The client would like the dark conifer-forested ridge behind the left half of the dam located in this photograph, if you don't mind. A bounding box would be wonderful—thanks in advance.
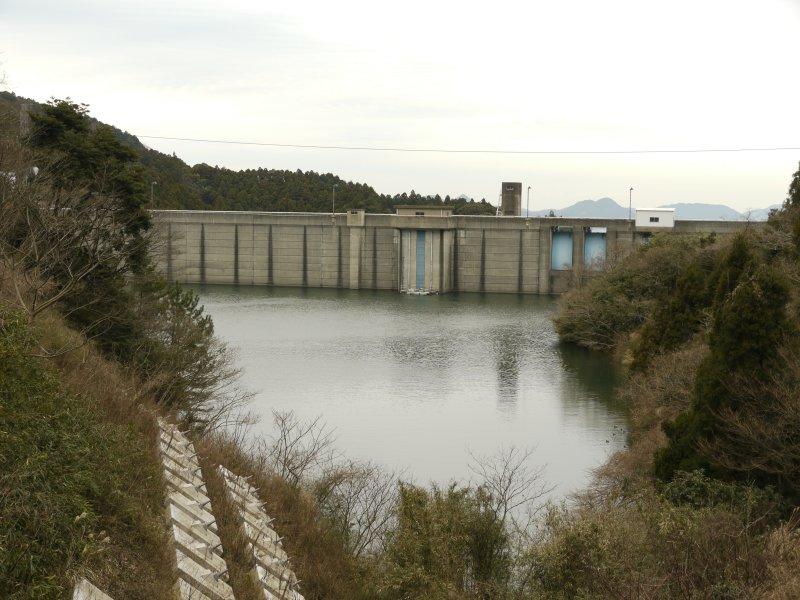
[0,92,496,215]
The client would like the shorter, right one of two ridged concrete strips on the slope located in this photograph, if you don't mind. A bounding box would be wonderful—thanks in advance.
[219,466,304,600]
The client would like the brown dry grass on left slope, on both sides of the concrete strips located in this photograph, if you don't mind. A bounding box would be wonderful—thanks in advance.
[0,258,366,600]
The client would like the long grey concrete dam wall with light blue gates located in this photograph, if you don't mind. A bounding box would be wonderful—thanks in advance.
[152,206,757,294]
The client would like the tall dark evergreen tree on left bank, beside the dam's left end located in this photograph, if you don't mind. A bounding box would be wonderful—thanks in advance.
[28,100,150,358]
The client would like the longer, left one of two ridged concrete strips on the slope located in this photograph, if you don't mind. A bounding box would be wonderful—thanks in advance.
[158,419,234,600]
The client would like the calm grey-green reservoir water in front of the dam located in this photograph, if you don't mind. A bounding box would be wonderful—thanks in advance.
[194,286,626,496]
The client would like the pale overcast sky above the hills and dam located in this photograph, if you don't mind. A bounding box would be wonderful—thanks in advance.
[0,0,800,210]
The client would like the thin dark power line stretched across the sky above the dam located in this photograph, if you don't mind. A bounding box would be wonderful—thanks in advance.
[138,135,800,154]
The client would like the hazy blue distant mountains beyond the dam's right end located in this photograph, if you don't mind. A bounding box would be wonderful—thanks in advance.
[530,198,781,221]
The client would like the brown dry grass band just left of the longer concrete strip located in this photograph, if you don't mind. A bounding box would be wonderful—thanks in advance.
[0,264,173,600]
